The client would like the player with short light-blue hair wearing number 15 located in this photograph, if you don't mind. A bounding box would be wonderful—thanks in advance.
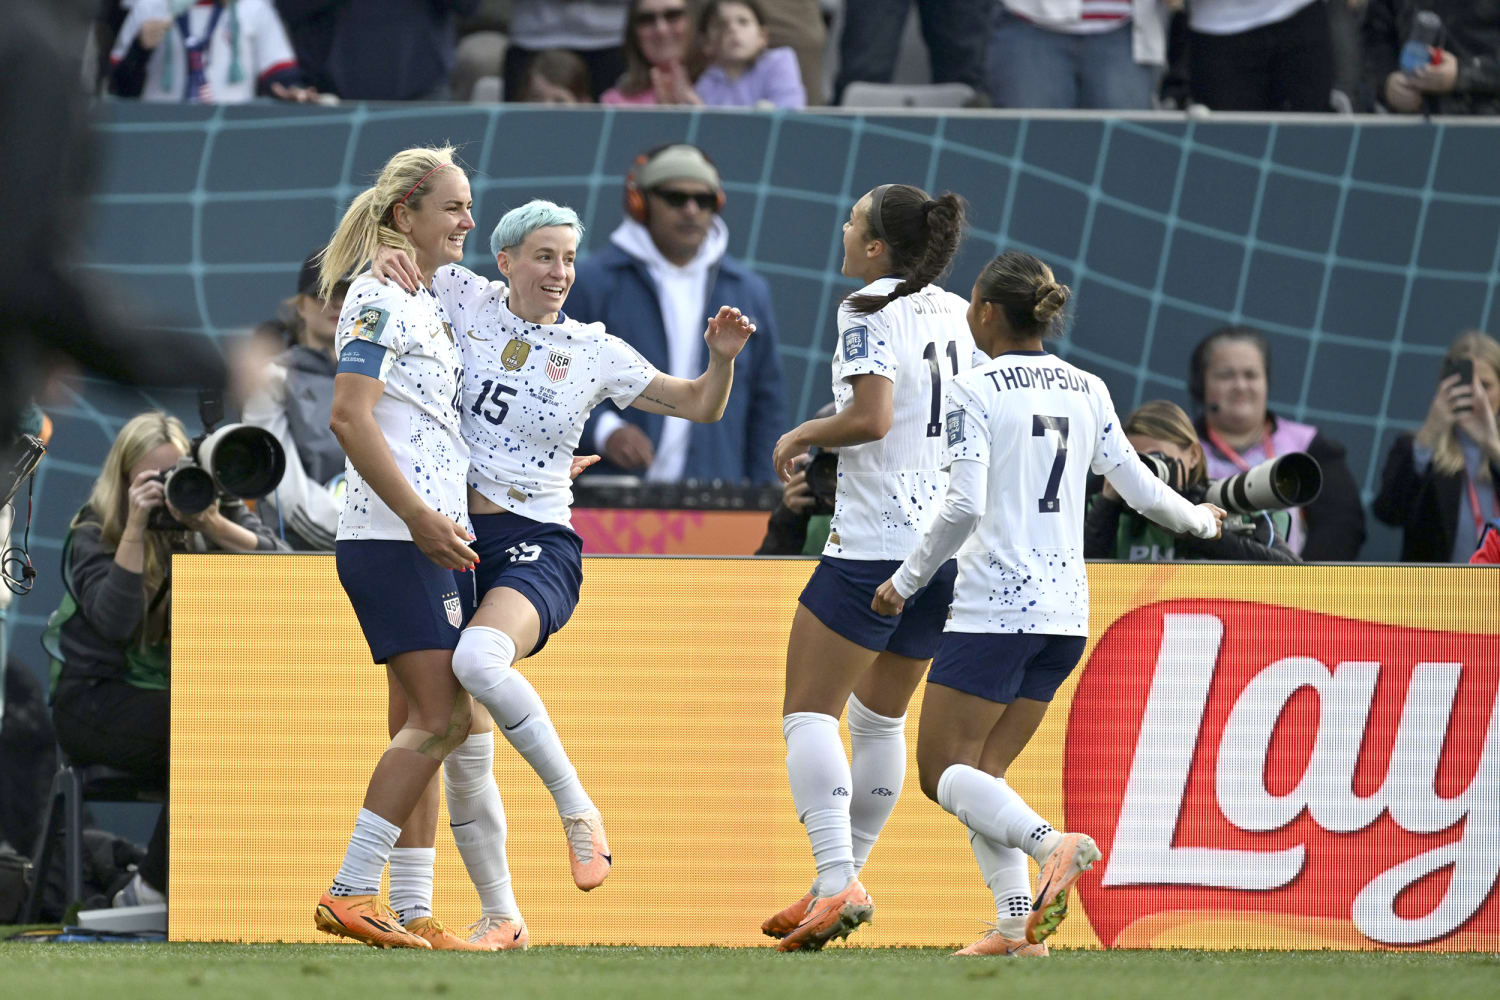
[377,201,755,929]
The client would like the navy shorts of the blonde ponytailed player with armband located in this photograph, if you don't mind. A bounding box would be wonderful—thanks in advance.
[333,538,464,663]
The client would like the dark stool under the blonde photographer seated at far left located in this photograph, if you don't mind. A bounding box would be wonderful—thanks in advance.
[21,750,167,924]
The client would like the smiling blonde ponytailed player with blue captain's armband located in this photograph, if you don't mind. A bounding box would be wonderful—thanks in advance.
[314,147,479,948]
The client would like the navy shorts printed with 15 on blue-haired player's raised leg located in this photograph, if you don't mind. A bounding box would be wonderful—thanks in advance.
[459,511,584,655]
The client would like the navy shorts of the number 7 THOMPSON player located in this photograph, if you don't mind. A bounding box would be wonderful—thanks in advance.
[927,633,1088,705]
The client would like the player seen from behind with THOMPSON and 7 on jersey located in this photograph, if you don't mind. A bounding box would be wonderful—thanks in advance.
[872,250,1224,957]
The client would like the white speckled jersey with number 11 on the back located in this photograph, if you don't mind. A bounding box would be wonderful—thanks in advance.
[824,277,975,559]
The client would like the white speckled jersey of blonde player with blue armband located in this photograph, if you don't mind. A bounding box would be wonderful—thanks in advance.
[336,274,470,541]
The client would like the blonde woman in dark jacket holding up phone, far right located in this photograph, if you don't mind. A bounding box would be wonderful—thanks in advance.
[1374,330,1500,562]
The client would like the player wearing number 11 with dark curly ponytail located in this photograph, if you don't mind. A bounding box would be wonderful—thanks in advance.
[761,184,974,952]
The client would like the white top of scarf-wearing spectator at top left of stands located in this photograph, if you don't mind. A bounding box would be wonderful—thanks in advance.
[110,0,297,103]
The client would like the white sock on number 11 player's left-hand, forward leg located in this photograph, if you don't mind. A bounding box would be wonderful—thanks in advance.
[782,712,855,897]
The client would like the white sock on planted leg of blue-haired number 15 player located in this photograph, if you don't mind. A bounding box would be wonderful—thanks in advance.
[443,732,521,919]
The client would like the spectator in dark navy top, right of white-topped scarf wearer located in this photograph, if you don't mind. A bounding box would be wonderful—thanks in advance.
[276,0,480,100]
